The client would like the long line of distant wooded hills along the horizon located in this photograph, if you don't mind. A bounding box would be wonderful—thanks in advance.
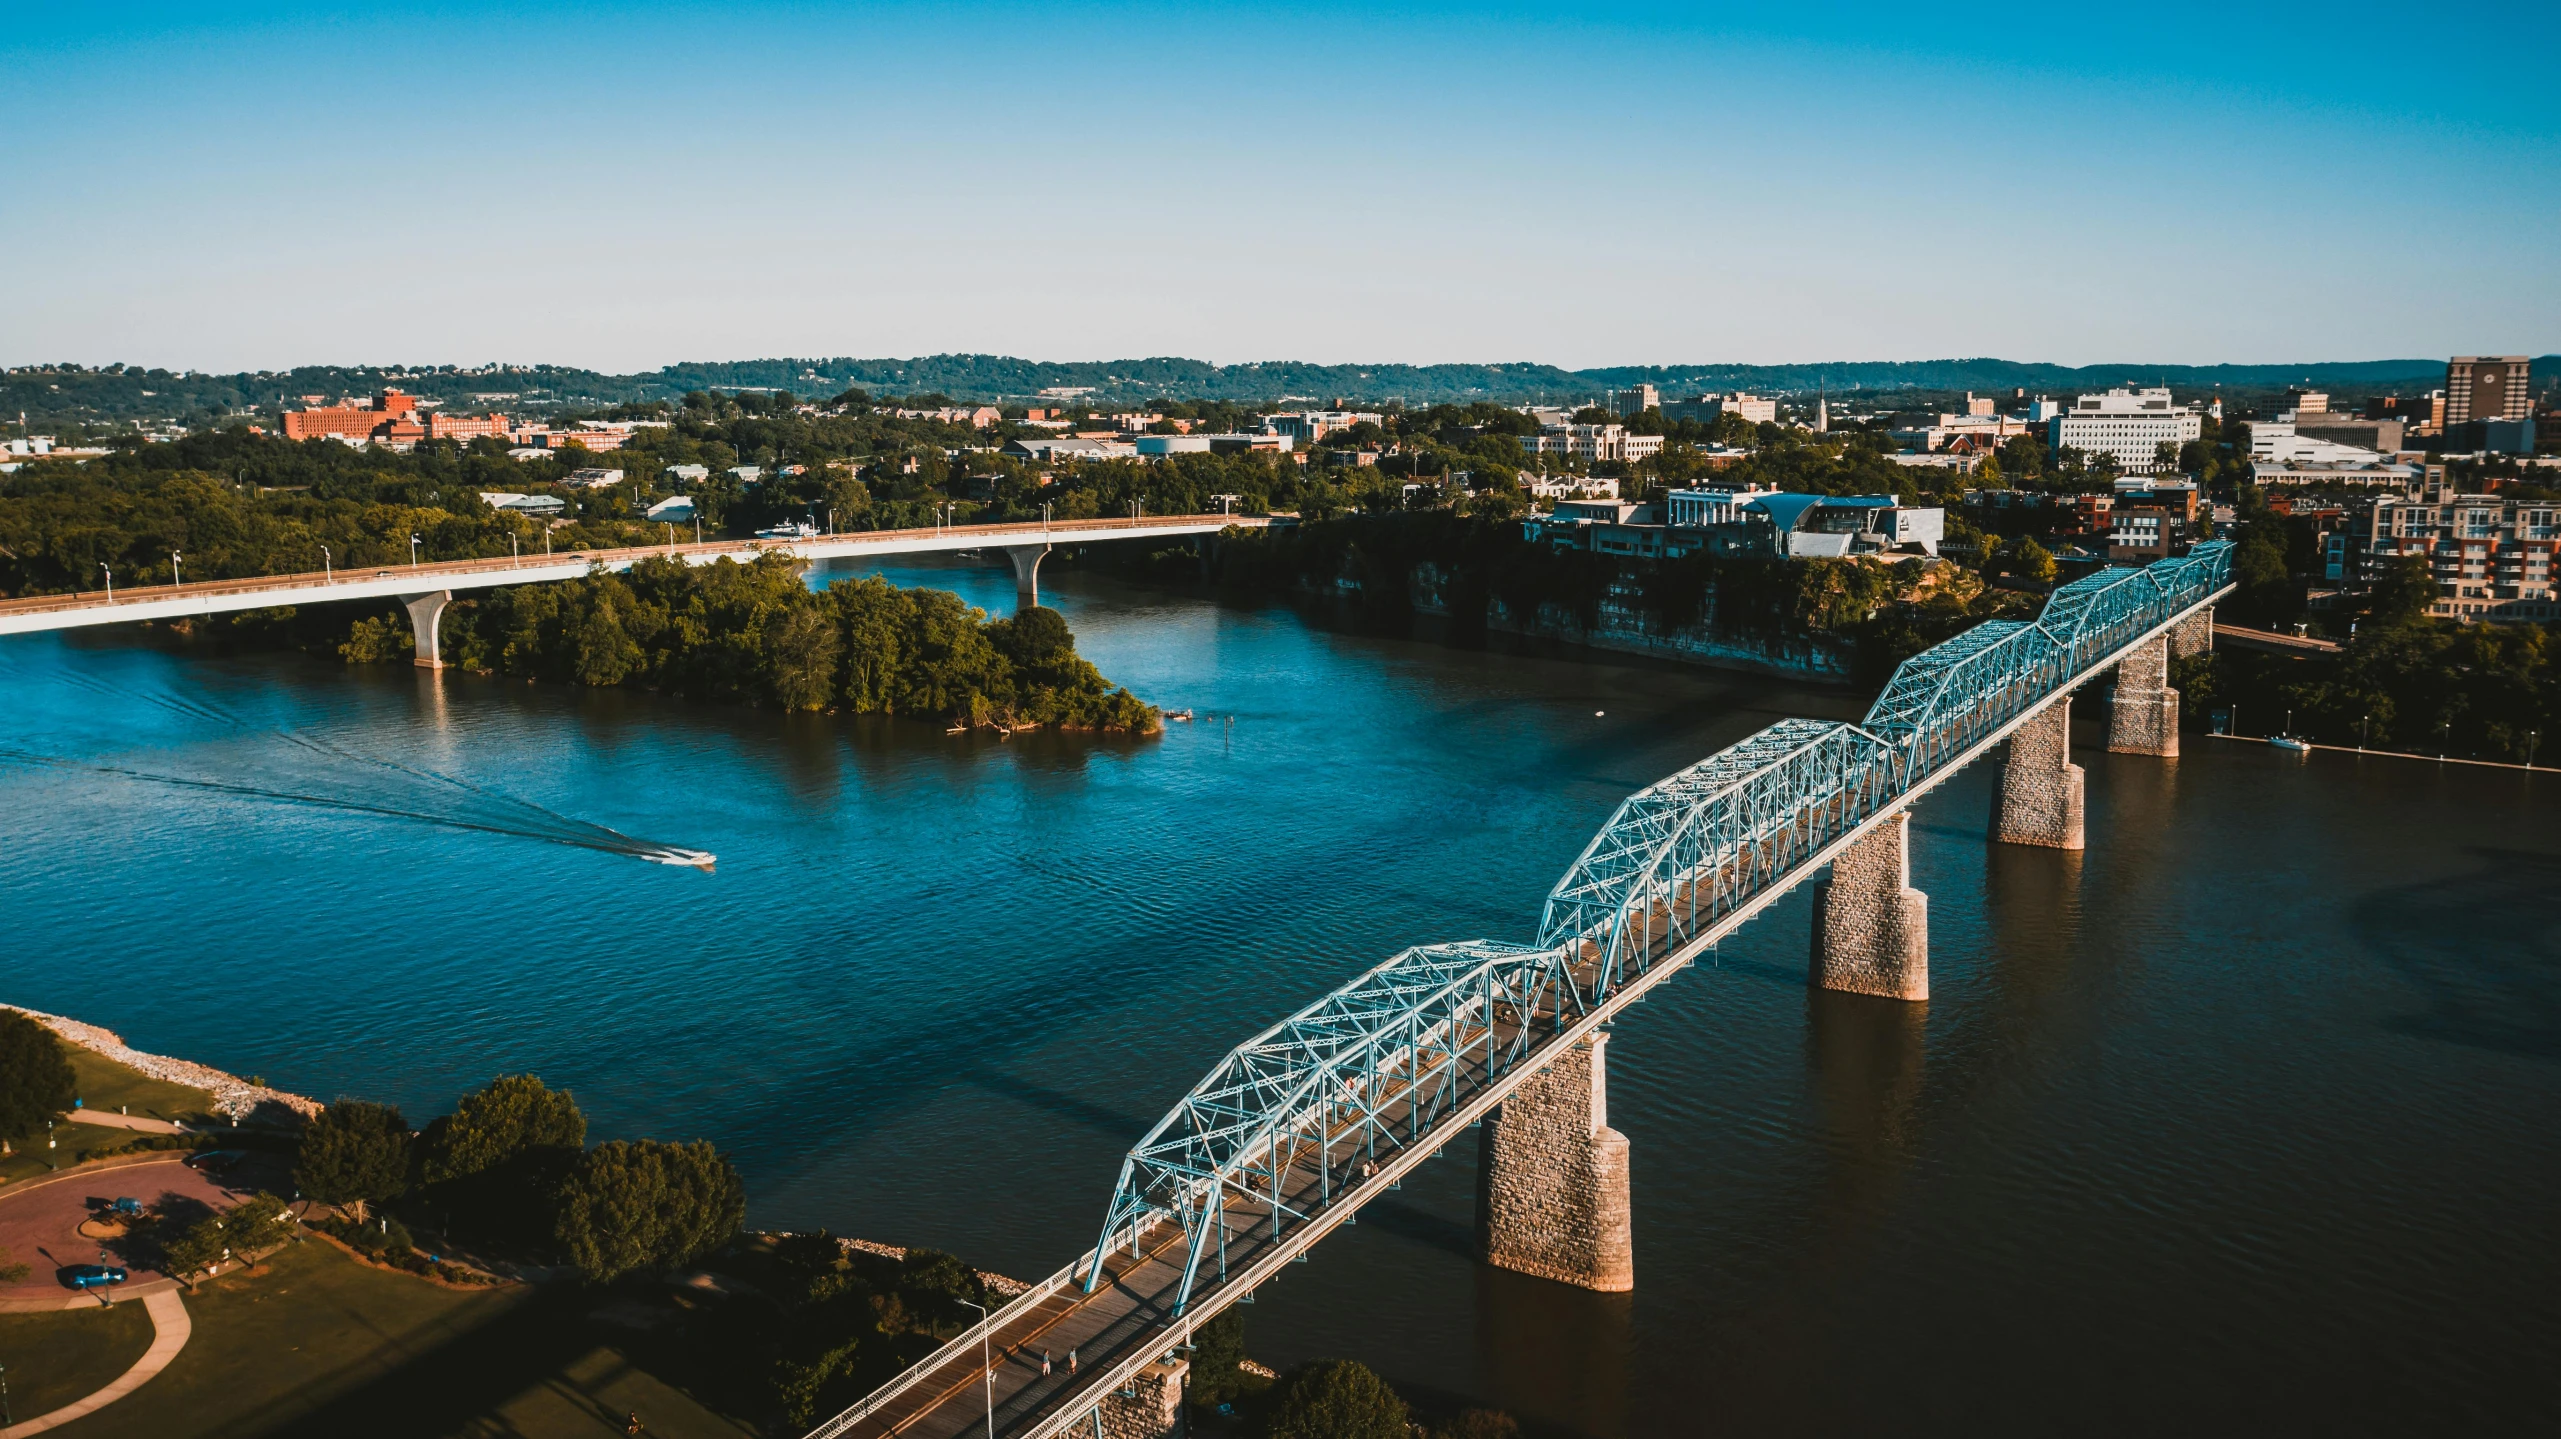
[0,356,2561,428]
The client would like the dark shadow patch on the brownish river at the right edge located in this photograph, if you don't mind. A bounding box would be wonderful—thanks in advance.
[2348,850,2561,1060]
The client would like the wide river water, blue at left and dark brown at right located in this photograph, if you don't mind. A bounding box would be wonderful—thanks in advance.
[0,555,2561,1436]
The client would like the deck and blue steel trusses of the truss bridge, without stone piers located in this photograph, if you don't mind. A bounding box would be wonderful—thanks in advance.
[809,545,2228,1439]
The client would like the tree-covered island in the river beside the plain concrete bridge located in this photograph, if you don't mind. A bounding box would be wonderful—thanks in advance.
[341,556,1160,735]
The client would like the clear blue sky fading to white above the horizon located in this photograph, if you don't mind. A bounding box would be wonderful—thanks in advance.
[0,0,2561,369]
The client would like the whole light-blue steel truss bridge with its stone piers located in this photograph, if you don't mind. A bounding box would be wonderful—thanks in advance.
[809,543,2231,1439]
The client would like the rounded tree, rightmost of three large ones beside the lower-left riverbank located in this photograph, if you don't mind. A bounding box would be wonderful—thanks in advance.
[553,1139,748,1283]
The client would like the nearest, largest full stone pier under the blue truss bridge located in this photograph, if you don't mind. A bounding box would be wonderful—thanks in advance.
[1478,1034,1636,1293]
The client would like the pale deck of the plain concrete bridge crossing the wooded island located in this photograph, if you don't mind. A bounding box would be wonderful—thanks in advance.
[0,515,1249,635]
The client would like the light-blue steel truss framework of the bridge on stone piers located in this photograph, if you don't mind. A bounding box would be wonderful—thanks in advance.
[1083,543,2231,1314]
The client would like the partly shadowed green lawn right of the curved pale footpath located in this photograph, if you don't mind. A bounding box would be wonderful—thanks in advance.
[49,1239,753,1439]
